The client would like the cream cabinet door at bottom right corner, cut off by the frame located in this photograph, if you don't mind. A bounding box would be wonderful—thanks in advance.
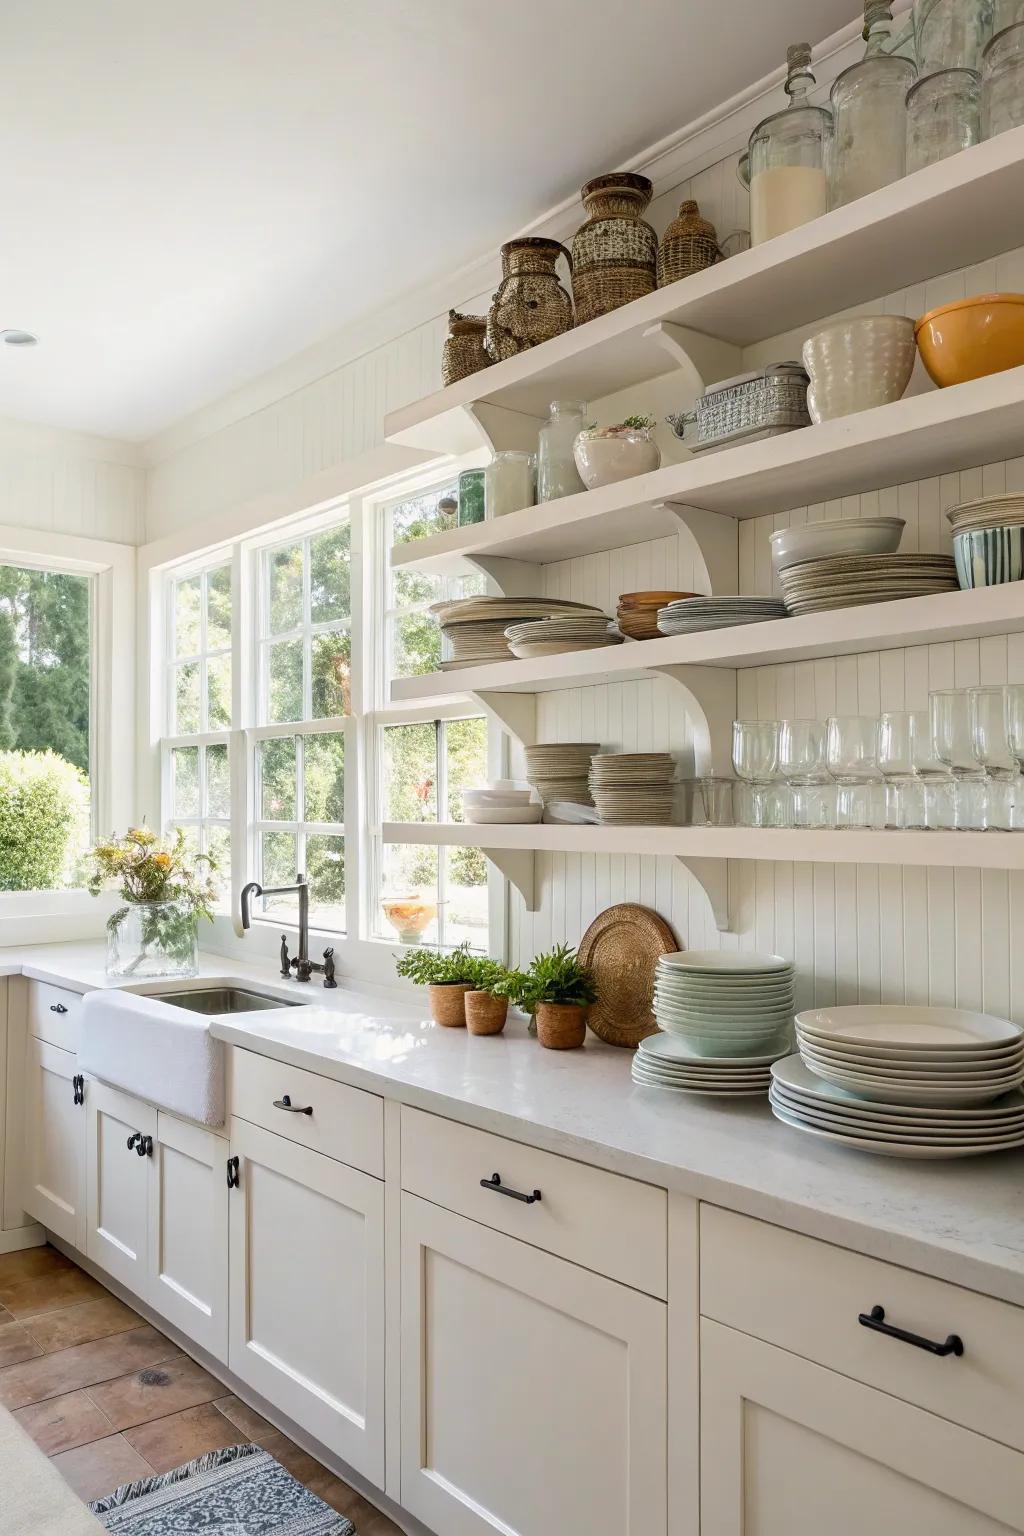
[700,1319,1024,1536]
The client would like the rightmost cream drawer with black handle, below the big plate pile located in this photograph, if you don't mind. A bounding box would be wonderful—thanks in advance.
[700,1206,1024,1450]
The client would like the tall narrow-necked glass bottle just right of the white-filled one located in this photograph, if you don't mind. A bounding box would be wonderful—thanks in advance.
[827,0,915,207]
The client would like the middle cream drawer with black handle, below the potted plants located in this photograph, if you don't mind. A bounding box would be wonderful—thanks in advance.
[402,1106,668,1298]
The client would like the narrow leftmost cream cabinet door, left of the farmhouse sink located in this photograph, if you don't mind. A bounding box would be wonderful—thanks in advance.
[21,1035,86,1249]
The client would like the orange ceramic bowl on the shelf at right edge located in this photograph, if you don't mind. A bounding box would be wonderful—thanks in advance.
[913,293,1024,389]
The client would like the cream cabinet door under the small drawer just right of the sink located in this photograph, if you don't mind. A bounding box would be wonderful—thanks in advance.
[227,1118,384,1487]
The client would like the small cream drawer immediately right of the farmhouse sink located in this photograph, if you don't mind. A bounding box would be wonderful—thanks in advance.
[227,1046,384,1178]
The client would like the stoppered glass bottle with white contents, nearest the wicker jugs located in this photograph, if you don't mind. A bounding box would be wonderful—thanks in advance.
[749,43,832,246]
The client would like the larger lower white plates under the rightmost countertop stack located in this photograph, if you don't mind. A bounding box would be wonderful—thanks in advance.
[768,1055,1024,1158]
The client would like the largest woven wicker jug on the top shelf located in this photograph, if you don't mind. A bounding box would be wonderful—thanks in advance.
[573,170,657,326]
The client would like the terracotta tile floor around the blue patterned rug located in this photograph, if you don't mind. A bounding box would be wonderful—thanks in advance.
[0,1247,401,1536]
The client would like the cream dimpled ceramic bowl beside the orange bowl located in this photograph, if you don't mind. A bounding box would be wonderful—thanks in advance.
[803,315,917,422]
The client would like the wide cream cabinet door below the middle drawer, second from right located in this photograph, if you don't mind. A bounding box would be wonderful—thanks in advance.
[401,1195,666,1536]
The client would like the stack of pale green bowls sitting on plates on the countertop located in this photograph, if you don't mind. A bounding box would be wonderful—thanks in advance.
[654,949,794,1057]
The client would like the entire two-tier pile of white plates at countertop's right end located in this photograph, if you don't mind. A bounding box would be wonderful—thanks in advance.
[771,1005,1024,1158]
